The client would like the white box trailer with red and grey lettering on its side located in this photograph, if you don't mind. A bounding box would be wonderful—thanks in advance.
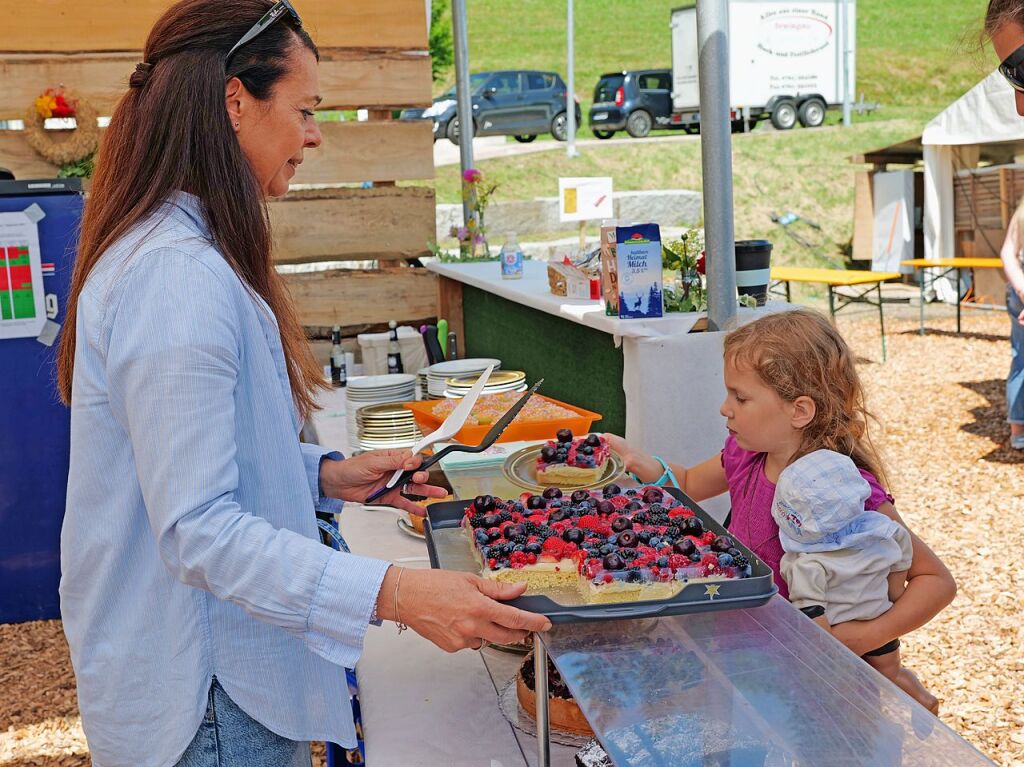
[671,0,857,132]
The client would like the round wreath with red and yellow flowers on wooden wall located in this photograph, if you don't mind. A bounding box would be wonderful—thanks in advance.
[25,88,99,166]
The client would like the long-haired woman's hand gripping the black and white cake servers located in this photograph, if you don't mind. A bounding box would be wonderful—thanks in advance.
[321,451,447,517]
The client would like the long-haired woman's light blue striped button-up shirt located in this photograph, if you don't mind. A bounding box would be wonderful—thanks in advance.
[60,194,388,767]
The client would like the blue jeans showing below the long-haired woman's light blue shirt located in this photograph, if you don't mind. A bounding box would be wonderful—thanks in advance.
[177,677,310,767]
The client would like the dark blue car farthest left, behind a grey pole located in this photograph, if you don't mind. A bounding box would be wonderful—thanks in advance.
[401,70,581,143]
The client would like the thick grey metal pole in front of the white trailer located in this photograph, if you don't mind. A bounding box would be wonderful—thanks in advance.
[697,0,736,331]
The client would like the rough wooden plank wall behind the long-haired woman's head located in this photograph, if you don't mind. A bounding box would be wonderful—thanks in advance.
[0,0,437,335]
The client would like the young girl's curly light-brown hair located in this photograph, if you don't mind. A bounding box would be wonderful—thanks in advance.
[725,309,887,486]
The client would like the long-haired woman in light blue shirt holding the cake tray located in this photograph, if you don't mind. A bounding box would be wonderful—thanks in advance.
[59,0,549,767]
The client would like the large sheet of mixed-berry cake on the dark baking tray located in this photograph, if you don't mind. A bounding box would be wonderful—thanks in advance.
[463,484,752,603]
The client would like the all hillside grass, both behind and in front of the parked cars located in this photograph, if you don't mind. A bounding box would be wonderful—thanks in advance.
[436,0,995,265]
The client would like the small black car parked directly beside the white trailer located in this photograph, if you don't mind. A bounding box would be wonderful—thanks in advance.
[590,70,673,138]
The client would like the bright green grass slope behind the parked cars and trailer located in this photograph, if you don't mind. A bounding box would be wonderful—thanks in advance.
[444,0,995,117]
